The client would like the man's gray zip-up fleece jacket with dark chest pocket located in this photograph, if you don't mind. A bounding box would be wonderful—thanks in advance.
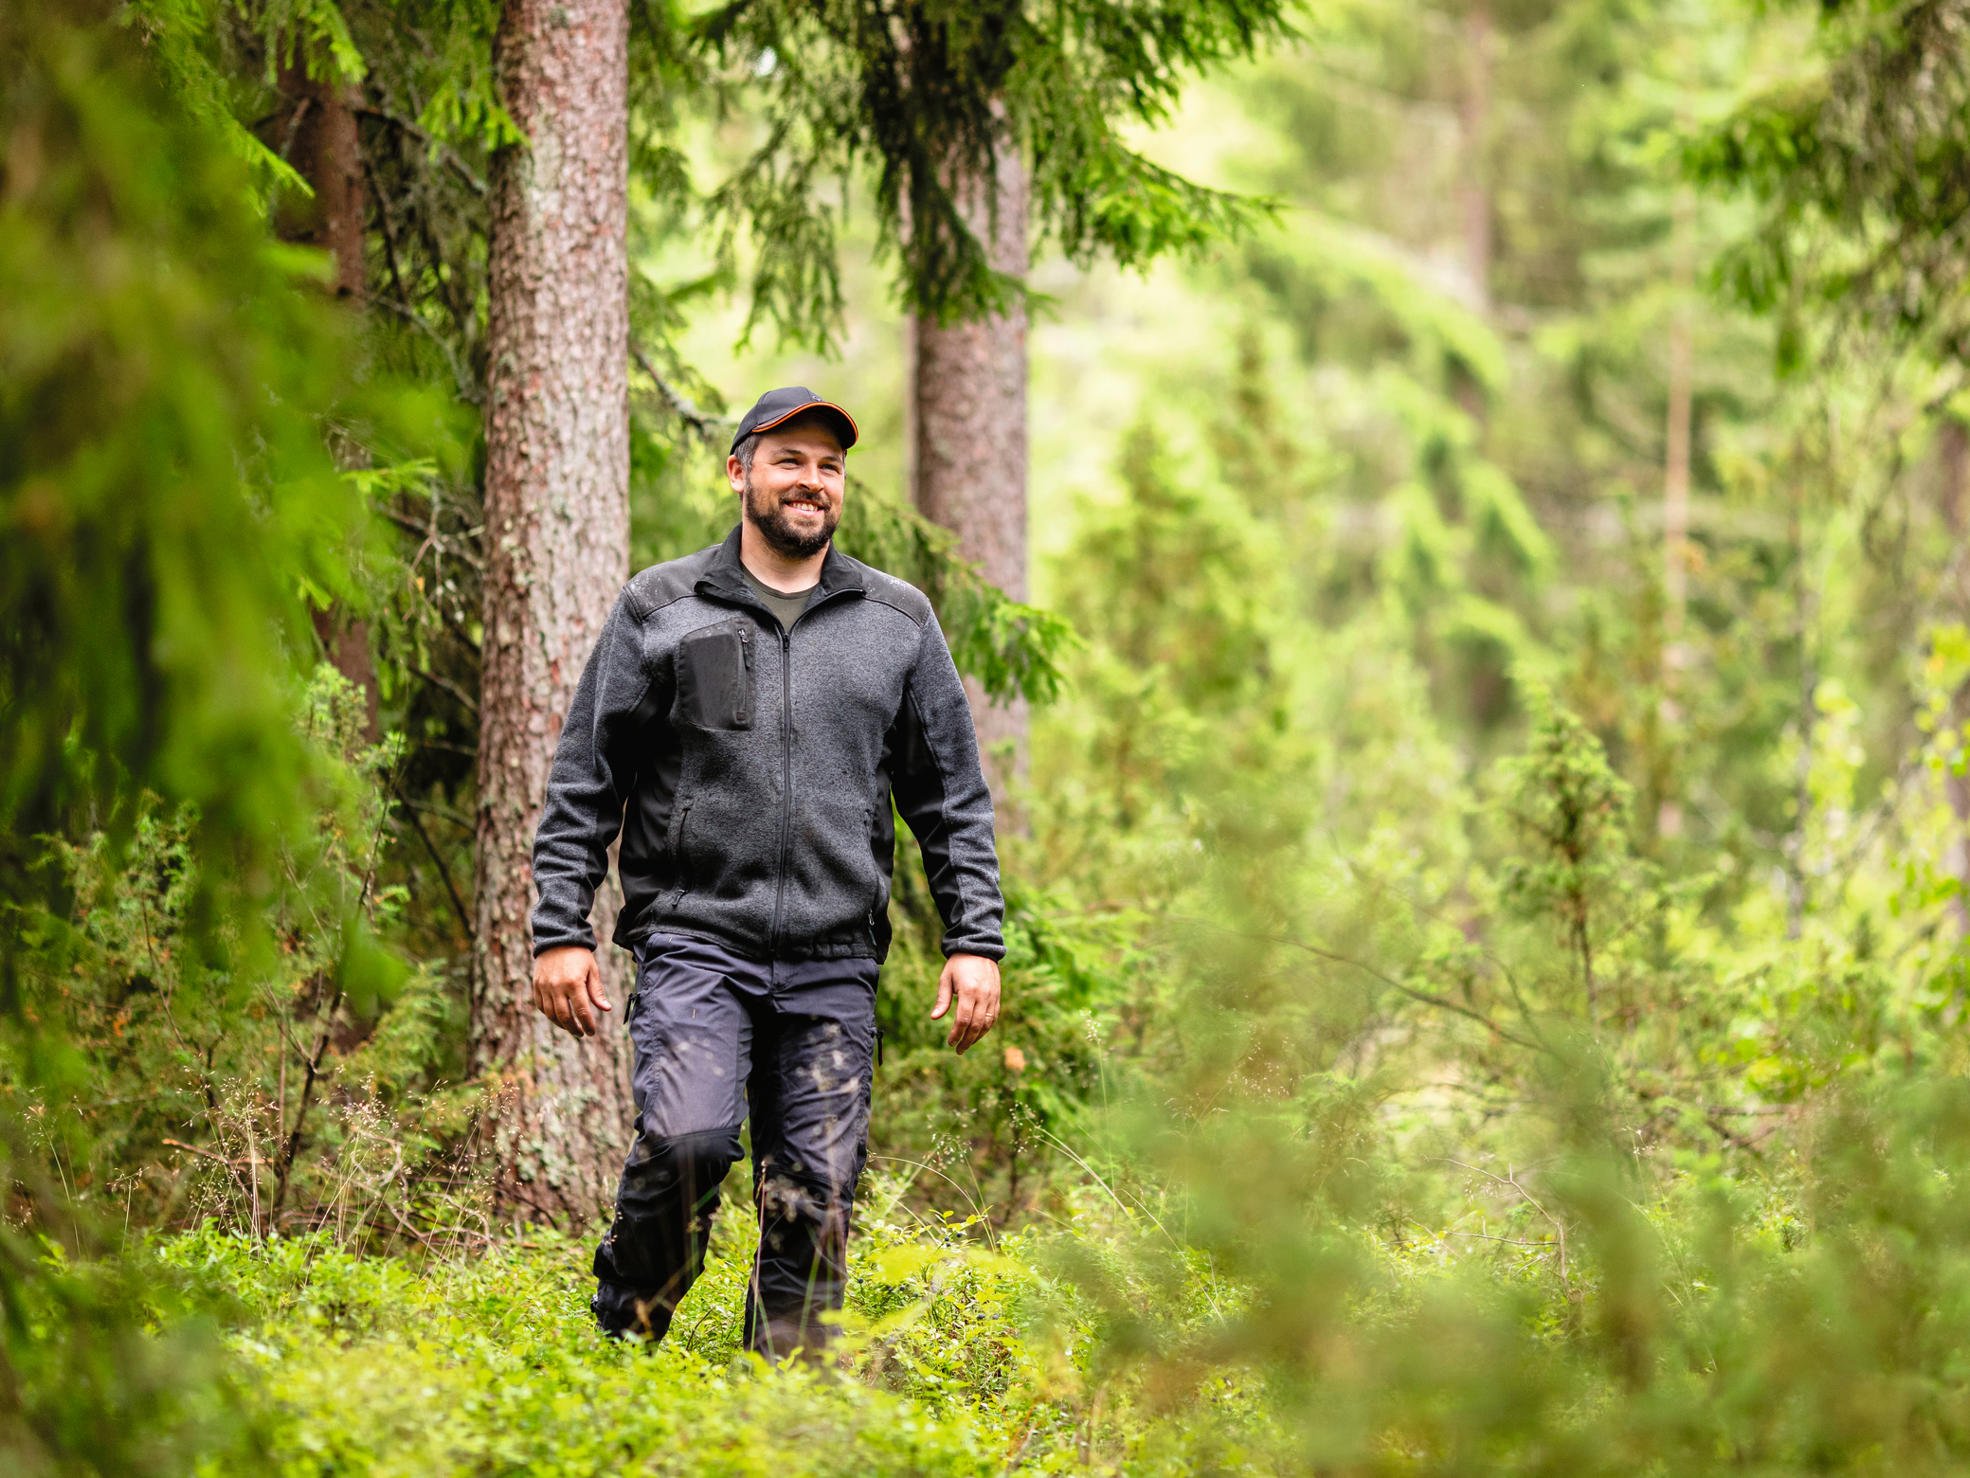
[534,528,1005,960]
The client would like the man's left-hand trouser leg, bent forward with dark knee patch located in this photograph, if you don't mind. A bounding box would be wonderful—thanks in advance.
[589,936,768,1338]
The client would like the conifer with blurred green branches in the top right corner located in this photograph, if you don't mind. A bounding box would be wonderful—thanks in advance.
[1686,0,1970,932]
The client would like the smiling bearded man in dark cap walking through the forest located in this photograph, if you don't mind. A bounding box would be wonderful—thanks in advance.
[534,386,1005,1356]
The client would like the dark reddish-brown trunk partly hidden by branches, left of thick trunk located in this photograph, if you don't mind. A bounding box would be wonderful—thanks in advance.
[274,52,380,743]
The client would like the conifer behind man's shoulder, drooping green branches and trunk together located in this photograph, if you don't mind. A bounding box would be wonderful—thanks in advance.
[701,0,1286,780]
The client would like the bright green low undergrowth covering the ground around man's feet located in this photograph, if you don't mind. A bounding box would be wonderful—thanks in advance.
[156,1182,1245,1474]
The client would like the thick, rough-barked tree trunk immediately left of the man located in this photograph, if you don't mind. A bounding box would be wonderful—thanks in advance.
[473,0,630,1220]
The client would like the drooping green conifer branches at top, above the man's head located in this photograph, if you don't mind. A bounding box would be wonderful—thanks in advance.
[697,0,1286,335]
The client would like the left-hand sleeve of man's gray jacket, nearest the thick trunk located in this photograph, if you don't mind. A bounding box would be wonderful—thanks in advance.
[534,589,654,956]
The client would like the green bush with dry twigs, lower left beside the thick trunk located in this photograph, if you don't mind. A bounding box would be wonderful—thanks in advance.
[4,668,459,1240]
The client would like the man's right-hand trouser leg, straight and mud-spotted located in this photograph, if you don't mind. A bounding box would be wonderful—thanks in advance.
[745,960,877,1358]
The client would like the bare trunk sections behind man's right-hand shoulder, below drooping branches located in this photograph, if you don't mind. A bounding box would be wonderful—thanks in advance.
[910,132,1026,812]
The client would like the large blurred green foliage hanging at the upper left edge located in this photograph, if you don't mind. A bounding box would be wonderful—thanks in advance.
[0,0,370,974]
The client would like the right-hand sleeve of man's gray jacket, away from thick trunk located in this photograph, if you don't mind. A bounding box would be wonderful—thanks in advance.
[888,615,1005,960]
